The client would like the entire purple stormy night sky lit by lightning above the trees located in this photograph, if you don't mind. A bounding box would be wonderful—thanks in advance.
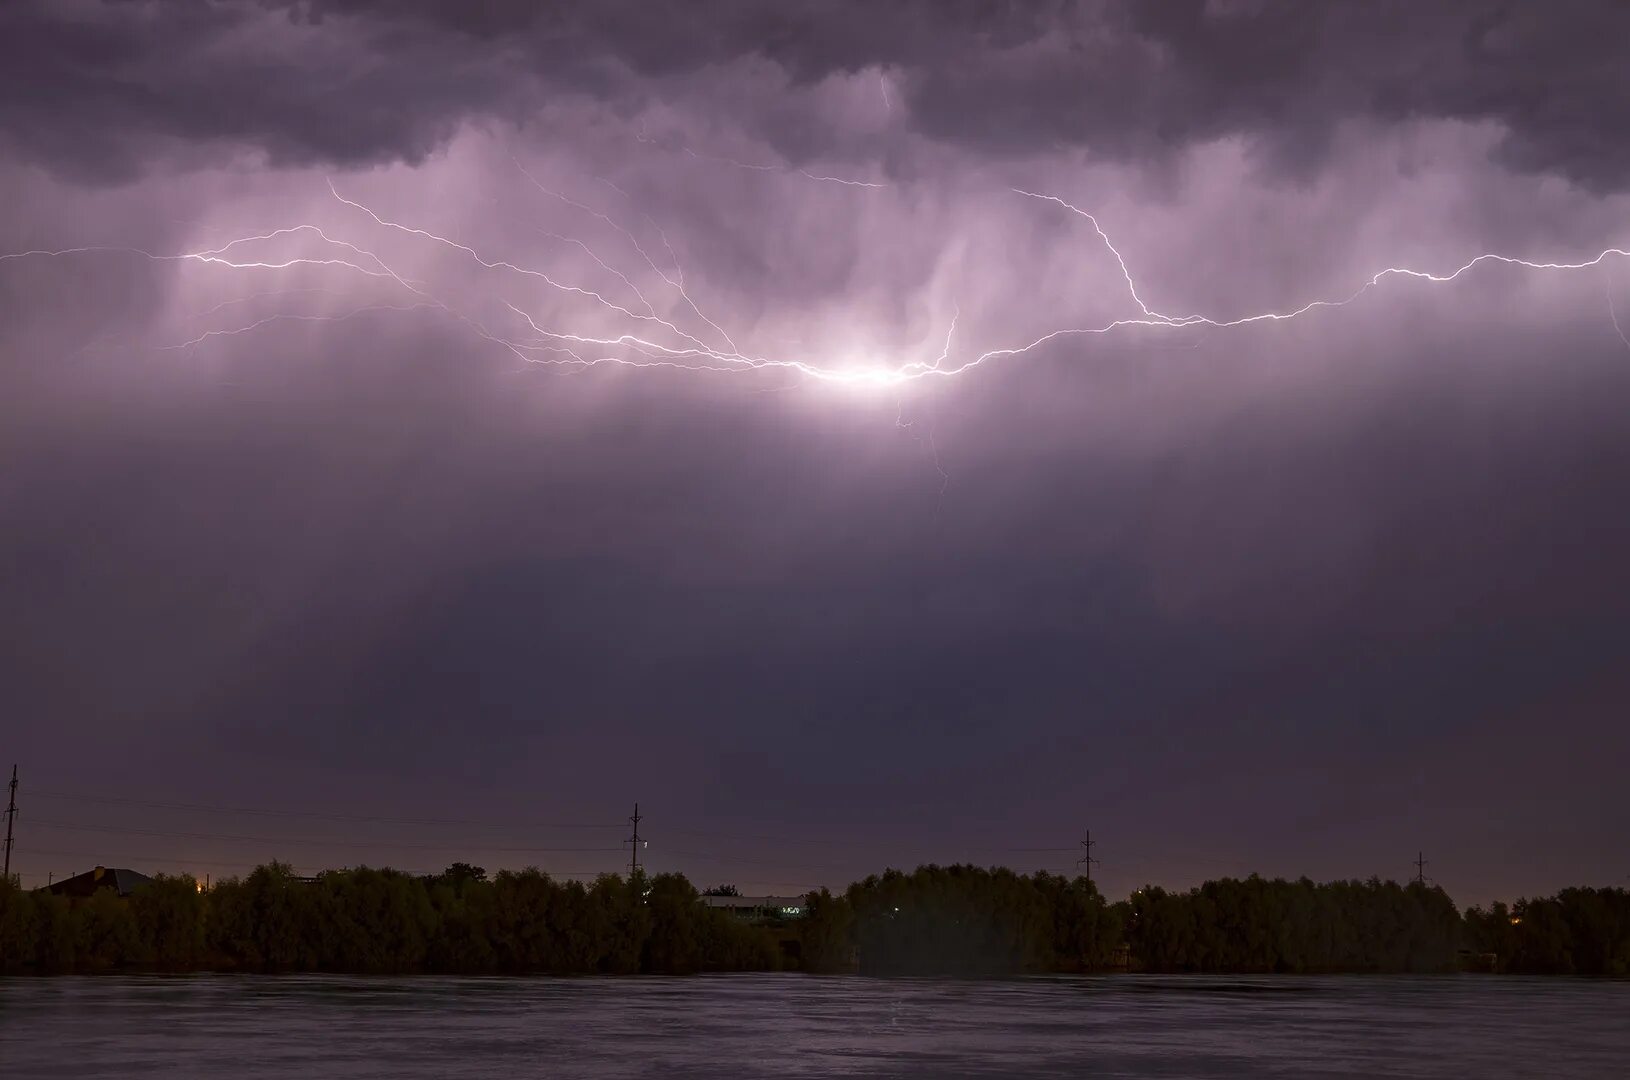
[0,0,1630,902]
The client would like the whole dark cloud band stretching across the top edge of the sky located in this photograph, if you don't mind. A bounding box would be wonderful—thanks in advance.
[9,0,1630,189]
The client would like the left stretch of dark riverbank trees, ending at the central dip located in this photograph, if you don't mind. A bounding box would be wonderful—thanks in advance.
[0,863,781,974]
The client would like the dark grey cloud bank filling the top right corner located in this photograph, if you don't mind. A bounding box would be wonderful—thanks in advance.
[913,0,1630,189]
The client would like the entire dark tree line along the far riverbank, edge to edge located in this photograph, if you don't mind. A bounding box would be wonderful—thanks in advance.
[0,863,1630,976]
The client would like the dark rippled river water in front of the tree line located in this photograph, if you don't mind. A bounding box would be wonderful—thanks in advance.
[0,976,1630,1080]
